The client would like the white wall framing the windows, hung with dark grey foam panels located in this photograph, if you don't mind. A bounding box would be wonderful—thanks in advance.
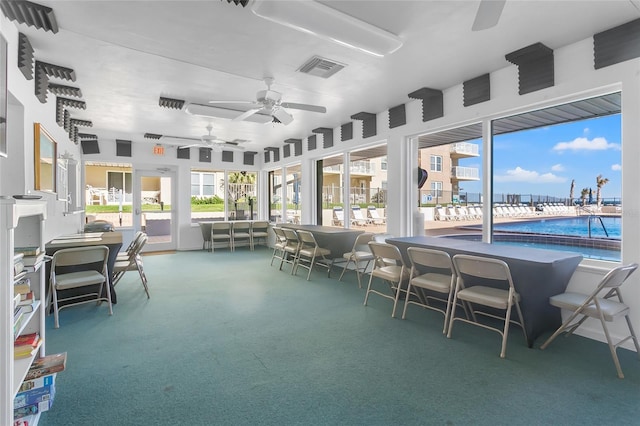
[0,17,640,347]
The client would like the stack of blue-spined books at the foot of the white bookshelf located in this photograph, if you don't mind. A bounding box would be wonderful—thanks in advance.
[13,352,67,419]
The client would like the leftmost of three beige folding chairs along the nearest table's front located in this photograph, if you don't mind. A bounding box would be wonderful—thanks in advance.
[364,241,409,317]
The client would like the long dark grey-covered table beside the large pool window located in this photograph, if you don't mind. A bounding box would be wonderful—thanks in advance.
[387,236,582,347]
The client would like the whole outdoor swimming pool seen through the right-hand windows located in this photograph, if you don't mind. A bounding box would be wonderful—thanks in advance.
[458,216,622,262]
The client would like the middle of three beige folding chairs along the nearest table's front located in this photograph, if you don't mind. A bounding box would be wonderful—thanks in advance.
[402,247,456,334]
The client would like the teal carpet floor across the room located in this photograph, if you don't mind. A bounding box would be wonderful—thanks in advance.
[40,247,640,426]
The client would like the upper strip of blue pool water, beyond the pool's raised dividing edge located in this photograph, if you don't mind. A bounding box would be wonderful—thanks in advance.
[493,216,622,240]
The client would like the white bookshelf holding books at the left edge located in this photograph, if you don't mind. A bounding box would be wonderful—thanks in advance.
[0,198,47,425]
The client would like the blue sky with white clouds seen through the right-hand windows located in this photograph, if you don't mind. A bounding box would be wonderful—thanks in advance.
[460,114,622,199]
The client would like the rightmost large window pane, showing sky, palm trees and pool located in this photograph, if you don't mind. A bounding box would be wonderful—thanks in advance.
[492,93,623,261]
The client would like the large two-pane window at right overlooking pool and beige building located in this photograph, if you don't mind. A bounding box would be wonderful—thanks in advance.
[418,92,624,261]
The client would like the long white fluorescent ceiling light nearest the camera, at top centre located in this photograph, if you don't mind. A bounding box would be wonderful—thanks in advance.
[251,0,402,57]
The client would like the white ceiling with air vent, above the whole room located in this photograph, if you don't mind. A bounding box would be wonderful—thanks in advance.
[10,0,640,151]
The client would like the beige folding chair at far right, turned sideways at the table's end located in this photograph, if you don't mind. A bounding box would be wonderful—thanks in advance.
[540,263,640,379]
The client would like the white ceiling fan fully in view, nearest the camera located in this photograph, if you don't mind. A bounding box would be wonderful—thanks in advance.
[209,77,327,125]
